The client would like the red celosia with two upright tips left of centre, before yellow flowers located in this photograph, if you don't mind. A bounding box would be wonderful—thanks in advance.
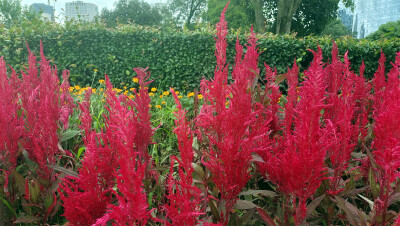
[96,73,153,225]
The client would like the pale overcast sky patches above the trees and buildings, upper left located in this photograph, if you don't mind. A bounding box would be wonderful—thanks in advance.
[21,0,167,15]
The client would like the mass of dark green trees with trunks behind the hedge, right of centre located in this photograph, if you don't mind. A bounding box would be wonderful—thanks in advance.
[203,0,354,37]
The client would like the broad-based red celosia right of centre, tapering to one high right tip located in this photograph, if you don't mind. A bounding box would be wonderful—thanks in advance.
[264,48,326,225]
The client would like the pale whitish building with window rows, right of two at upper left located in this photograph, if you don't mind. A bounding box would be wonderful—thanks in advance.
[65,1,99,21]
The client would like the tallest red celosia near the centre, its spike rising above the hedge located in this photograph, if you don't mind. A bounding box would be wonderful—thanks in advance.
[196,3,268,224]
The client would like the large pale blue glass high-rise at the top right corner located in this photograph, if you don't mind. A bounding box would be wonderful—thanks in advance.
[352,0,400,38]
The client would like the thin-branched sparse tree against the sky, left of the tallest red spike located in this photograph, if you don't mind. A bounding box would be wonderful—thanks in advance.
[169,0,206,29]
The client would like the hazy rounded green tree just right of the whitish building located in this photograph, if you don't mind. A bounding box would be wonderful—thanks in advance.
[100,0,162,27]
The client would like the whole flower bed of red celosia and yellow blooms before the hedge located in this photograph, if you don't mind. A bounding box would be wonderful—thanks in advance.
[0,8,400,226]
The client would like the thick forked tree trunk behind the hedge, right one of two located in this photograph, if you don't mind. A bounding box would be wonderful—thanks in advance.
[276,0,302,34]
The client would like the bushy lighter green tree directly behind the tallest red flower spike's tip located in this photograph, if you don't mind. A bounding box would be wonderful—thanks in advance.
[202,0,255,29]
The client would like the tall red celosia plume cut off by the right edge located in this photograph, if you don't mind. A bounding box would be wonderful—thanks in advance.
[372,53,400,225]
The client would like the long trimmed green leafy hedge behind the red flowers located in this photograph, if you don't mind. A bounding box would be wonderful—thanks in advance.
[0,20,400,90]
